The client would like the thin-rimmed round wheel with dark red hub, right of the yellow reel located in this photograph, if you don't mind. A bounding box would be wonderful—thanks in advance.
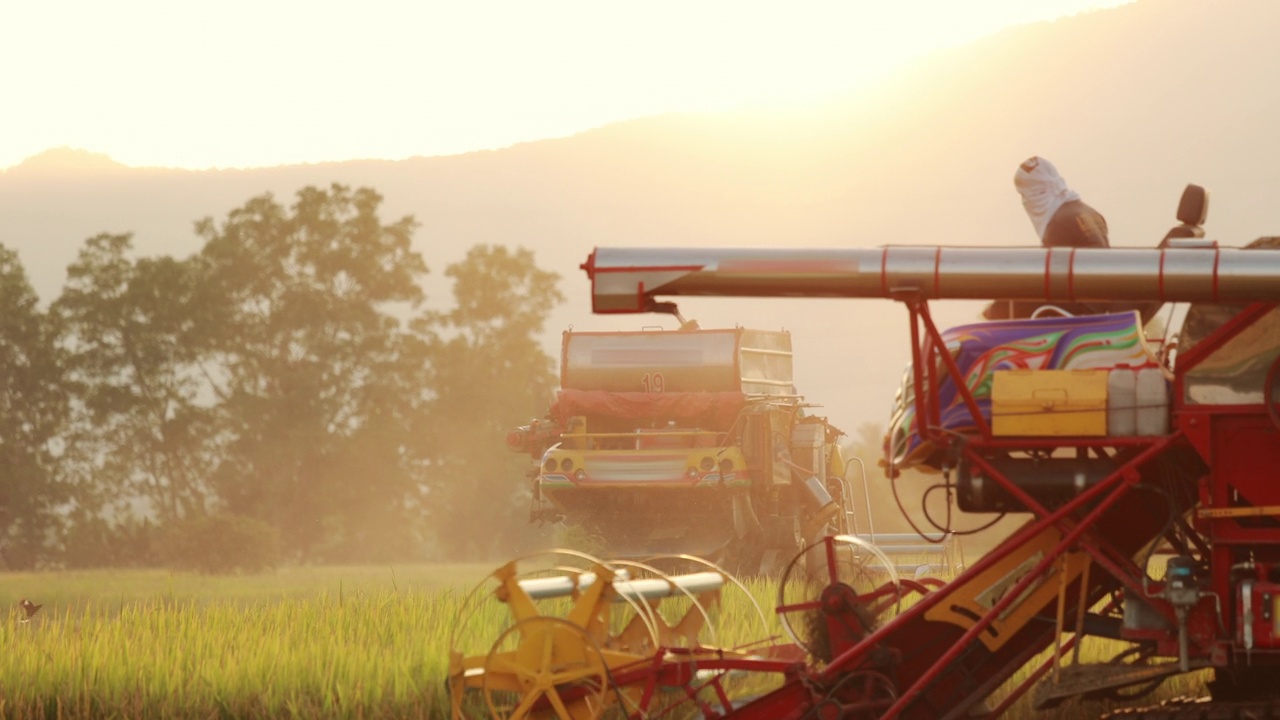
[777,536,902,659]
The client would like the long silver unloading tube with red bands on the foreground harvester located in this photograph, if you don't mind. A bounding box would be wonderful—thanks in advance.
[582,246,1280,313]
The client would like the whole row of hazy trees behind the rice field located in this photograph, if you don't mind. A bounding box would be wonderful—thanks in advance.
[0,184,563,571]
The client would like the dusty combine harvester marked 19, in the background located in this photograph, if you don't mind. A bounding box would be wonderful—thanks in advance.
[507,318,954,575]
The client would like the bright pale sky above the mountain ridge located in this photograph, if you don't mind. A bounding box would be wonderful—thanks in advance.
[0,0,1128,168]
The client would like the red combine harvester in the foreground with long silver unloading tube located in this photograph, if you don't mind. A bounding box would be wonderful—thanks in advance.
[454,186,1280,720]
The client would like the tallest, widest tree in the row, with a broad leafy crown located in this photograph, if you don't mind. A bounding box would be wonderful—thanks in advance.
[196,184,428,560]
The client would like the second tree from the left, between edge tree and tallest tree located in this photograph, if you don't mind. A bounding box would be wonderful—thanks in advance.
[51,234,216,524]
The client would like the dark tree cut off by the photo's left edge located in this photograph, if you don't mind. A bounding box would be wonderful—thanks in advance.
[0,246,67,569]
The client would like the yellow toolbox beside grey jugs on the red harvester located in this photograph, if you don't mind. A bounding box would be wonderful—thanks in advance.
[991,370,1107,437]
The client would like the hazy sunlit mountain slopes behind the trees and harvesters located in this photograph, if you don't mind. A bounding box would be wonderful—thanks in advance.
[0,0,1280,561]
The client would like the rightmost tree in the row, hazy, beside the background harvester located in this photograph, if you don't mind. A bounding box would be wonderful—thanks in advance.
[419,246,563,559]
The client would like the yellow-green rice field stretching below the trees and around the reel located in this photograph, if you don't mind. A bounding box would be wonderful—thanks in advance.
[0,565,1201,719]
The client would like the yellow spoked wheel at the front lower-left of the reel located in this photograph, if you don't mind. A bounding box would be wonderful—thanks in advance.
[483,616,609,720]
